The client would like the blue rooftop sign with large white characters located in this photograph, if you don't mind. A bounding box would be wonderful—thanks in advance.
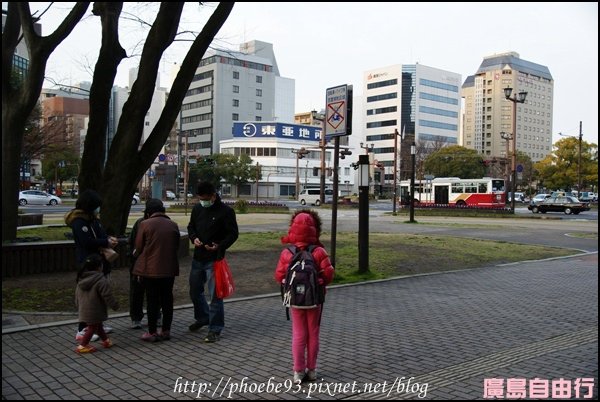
[233,122,323,141]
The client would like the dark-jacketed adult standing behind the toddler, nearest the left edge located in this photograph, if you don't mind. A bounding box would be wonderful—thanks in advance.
[65,189,118,341]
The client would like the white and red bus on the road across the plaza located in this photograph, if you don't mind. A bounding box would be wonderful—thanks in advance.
[399,177,506,208]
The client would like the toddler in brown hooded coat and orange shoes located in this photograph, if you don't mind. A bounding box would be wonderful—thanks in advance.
[75,254,119,353]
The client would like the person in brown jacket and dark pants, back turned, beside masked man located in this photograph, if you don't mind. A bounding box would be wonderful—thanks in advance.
[132,198,180,342]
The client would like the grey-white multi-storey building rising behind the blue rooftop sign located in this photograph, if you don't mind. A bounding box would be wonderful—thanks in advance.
[180,40,295,156]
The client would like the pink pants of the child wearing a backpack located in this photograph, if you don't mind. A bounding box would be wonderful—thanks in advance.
[290,306,321,371]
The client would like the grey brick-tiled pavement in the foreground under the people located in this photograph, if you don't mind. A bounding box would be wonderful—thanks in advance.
[2,253,598,400]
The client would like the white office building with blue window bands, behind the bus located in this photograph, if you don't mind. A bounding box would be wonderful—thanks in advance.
[362,64,461,193]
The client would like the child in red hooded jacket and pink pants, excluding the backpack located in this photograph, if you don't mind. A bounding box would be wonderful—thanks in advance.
[275,210,334,383]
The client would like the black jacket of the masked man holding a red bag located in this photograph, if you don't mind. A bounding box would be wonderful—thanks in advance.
[187,195,239,261]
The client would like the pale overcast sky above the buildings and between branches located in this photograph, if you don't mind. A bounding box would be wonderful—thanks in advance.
[31,2,598,144]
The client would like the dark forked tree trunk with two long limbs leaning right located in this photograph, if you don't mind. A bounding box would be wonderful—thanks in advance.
[96,3,234,235]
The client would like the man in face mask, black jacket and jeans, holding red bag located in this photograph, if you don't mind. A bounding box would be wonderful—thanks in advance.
[188,182,239,343]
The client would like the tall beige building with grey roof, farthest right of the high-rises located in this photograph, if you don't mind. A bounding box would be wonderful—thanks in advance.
[460,52,554,162]
